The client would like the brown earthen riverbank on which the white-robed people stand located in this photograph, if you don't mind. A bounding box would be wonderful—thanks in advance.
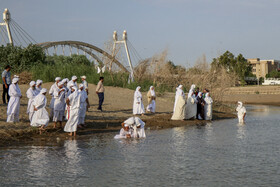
[0,83,235,146]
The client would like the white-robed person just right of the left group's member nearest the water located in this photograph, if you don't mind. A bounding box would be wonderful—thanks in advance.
[79,84,90,126]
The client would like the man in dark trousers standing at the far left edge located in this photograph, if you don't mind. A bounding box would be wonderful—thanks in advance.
[2,65,11,104]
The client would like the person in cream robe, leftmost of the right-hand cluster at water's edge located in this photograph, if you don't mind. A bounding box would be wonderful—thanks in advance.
[171,85,186,120]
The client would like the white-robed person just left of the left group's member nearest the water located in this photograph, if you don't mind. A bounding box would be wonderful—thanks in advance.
[53,82,66,128]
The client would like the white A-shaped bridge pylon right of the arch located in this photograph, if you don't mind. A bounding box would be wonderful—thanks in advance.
[109,30,134,82]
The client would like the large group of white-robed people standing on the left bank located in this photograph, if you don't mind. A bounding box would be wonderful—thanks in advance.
[7,76,90,136]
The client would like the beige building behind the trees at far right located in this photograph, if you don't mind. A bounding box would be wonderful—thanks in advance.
[247,58,280,78]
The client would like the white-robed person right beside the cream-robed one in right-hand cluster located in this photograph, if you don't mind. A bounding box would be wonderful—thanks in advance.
[185,84,197,119]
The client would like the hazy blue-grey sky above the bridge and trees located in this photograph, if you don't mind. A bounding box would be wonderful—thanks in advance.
[0,0,280,67]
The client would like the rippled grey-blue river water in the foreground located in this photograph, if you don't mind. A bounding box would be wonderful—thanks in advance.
[0,106,280,186]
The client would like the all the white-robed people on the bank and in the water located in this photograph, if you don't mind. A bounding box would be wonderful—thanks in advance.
[7,76,246,138]
